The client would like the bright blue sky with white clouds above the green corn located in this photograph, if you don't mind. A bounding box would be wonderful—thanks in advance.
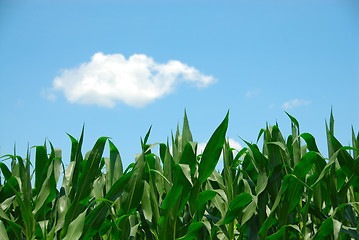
[0,0,359,171]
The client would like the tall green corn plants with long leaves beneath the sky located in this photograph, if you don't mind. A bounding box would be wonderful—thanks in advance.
[0,110,359,240]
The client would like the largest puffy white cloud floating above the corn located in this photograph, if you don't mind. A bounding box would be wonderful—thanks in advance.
[47,52,216,108]
